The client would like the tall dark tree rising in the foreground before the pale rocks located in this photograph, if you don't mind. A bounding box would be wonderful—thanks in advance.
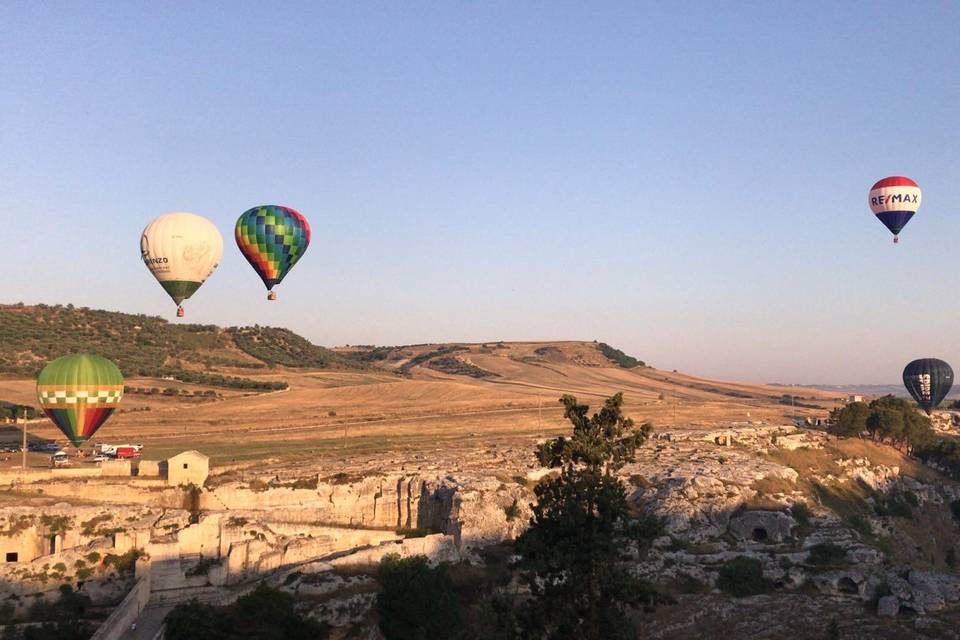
[516,393,662,640]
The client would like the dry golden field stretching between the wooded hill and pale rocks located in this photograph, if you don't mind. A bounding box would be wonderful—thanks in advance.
[0,342,838,464]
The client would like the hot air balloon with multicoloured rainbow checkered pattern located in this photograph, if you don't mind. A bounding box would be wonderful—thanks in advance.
[235,205,310,300]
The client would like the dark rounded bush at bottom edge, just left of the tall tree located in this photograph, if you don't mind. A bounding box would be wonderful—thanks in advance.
[377,554,463,640]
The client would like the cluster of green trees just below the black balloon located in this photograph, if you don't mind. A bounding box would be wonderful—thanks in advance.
[827,396,934,451]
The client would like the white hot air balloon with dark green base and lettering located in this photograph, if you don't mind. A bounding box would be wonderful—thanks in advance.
[140,213,223,318]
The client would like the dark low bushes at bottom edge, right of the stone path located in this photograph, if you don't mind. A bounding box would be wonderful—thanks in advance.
[164,583,328,640]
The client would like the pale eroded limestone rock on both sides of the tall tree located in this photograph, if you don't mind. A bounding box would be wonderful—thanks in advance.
[11,427,960,626]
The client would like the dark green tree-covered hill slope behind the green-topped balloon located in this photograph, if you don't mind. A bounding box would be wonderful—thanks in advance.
[0,304,358,377]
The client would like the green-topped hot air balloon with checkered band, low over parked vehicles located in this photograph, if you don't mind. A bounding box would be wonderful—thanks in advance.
[37,353,123,447]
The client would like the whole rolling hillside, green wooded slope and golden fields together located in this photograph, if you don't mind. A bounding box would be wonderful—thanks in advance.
[0,306,841,462]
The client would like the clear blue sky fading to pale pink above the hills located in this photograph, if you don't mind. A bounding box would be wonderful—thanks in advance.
[0,1,960,383]
